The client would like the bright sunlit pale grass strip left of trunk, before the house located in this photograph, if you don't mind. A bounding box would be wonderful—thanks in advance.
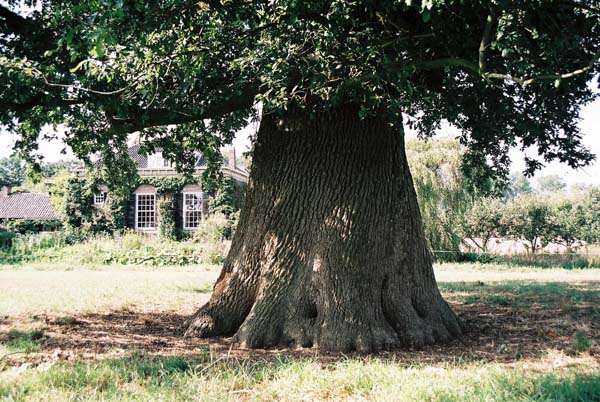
[0,265,219,317]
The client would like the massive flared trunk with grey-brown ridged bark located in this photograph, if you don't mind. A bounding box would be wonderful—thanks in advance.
[186,105,461,353]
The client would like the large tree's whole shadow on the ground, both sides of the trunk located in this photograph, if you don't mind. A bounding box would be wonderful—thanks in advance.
[0,282,600,370]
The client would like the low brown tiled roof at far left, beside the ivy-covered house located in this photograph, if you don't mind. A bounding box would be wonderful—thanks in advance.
[0,193,60,220]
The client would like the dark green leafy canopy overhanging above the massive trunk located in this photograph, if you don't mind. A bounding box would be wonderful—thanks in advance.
[0,0,600,184]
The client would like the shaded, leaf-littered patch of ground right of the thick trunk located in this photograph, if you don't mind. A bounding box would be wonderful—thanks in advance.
[440,281,600,359]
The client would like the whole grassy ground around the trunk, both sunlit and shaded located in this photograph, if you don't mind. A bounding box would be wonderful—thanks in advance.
[0,264,600,401]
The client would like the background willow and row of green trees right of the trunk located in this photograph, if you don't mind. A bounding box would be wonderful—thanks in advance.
[407,139,600,253]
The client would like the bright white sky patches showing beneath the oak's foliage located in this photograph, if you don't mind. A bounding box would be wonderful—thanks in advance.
[0,99,600,186]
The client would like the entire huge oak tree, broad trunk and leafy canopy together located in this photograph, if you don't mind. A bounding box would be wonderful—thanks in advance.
[0,0,600,352]
